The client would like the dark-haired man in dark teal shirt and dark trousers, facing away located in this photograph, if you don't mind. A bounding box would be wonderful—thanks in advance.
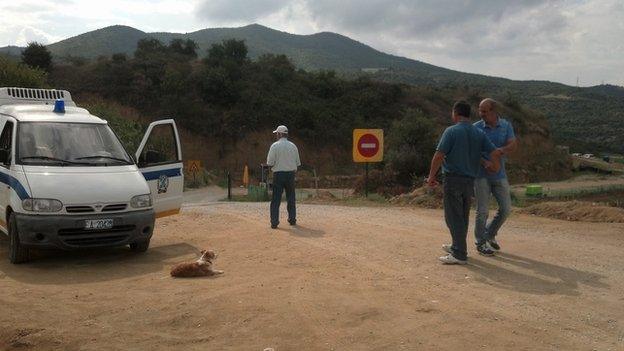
[427,101,500,264]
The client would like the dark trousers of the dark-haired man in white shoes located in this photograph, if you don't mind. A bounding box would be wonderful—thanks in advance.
[444,175,474,260]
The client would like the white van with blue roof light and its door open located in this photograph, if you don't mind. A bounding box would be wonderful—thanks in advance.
[0,88,183,263]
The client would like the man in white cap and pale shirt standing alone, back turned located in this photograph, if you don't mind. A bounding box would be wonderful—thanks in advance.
[267,126,301,229]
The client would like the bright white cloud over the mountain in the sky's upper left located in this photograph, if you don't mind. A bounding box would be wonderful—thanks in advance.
[0,0,203,46]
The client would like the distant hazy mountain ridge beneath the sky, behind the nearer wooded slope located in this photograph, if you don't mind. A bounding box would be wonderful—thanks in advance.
[0,24,624,152]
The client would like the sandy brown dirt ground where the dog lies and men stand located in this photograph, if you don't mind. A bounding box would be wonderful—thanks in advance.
[0,203,624,350]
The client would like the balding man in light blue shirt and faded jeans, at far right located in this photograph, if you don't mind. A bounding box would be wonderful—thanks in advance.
[474,98,517,256]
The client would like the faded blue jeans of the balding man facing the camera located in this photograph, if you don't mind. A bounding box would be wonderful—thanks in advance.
[475,178,511,245]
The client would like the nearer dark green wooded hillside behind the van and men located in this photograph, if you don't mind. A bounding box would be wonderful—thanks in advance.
[0,39,569,186]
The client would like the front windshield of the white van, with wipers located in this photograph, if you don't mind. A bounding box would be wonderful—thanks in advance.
[17,122,134,166]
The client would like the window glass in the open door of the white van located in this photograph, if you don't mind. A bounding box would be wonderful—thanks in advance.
[139,124,179,167]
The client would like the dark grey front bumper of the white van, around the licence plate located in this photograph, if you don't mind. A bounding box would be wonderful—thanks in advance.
[14,210,156,250]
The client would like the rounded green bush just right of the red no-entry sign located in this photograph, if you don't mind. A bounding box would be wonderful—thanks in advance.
[386,109,436,186]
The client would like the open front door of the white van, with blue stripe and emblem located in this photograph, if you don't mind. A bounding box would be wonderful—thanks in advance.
[136,119,184,218]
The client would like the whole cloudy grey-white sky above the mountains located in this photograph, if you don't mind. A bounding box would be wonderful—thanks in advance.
[0,0,624,86]
